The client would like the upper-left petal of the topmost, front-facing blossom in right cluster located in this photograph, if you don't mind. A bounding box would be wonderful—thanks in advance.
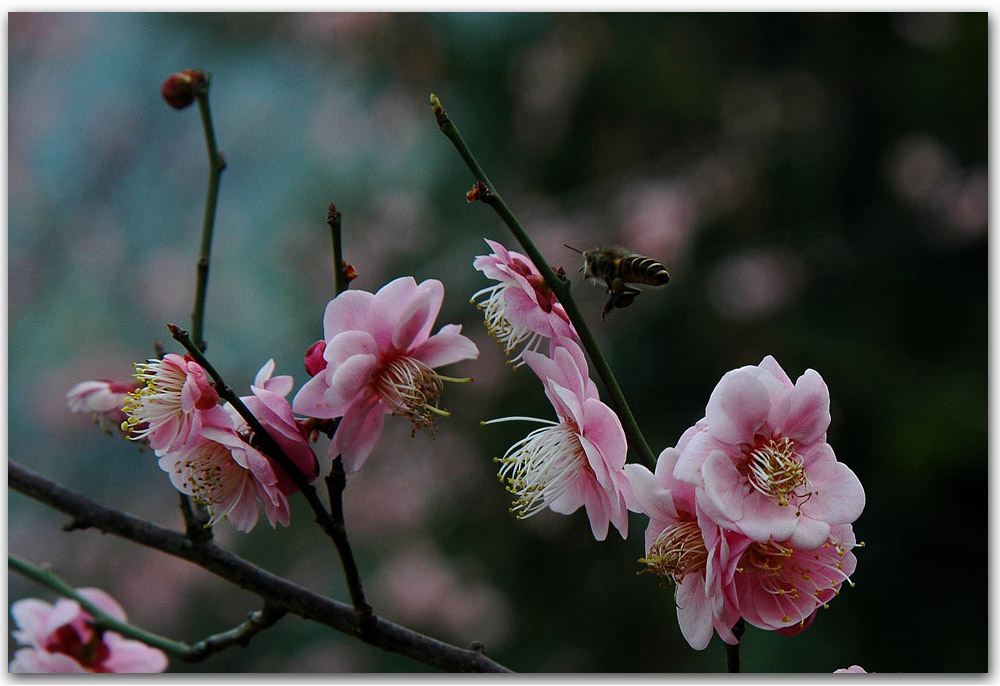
[705,367,771,445]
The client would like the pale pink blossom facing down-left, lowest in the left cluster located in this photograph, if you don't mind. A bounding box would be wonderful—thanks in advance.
[159,406,290,532]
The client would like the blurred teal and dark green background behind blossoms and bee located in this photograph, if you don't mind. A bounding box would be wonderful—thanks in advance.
[8,13,988,672]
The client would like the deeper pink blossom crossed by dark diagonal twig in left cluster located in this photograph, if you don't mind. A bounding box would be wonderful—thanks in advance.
[226,360,319,495]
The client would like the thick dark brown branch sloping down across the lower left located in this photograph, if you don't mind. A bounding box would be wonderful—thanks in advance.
[13,461,510,672]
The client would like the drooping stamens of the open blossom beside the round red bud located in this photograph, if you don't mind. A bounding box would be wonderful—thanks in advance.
[375,356,462,432]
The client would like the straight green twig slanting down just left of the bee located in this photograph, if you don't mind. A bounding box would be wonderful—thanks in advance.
[431,93,656,468]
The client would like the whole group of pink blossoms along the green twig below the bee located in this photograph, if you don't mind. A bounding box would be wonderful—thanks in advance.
[473,241,865,650]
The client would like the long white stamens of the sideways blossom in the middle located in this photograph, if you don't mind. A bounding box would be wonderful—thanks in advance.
[493,418,589,519]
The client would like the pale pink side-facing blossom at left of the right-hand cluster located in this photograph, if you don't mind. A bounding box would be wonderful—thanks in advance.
[625,448,751,650]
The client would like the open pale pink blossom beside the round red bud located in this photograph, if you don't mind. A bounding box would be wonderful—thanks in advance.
[292,276,479,472]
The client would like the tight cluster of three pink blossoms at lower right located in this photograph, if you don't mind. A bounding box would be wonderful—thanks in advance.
[625,356,865,650]
